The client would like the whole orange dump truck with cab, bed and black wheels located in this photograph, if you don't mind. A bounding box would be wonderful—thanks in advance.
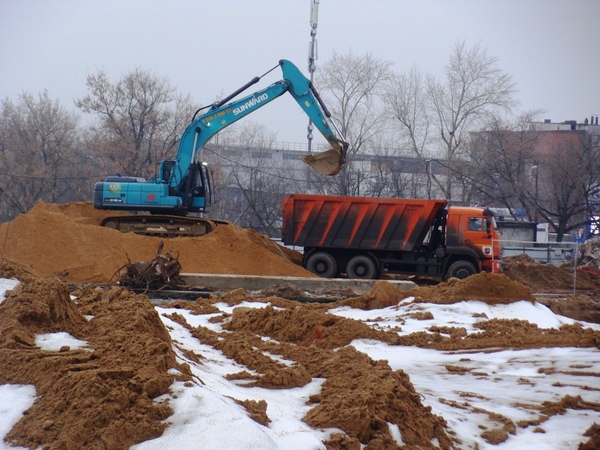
[282,194,500,279]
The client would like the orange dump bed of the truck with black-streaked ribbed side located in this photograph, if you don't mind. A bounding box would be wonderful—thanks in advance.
[282,194,447,251]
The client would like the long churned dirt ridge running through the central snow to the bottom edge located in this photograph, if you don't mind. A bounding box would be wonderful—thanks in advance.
[169,298,456,449]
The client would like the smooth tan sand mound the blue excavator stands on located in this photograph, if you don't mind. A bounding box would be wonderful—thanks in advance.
[0,202,314,283]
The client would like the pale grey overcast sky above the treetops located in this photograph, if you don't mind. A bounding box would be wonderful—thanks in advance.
[0,0,600,142]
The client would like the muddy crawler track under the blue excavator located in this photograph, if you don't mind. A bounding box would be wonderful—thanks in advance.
[100,214,230,238]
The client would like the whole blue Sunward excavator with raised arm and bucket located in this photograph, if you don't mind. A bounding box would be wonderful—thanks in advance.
[94,60,348,237]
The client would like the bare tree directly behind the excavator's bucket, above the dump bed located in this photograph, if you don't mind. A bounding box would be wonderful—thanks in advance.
[309,52,391,195]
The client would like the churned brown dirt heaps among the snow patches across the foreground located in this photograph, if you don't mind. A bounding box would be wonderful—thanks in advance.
[0,260,599,450]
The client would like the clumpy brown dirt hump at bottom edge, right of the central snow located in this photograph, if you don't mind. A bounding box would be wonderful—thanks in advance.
[304,347,456,449]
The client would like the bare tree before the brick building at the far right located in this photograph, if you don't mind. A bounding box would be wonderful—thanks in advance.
[463,112,600,241]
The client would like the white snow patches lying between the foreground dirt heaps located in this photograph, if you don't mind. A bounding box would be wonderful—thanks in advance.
[0,279,600,450]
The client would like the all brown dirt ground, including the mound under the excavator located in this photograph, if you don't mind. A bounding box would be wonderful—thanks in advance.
[0,203,600,449]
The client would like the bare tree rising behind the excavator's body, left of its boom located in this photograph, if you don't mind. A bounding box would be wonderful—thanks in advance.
[76,69,194,176]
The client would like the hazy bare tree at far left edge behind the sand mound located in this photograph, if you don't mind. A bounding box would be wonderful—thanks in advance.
[0,91,84,220]
